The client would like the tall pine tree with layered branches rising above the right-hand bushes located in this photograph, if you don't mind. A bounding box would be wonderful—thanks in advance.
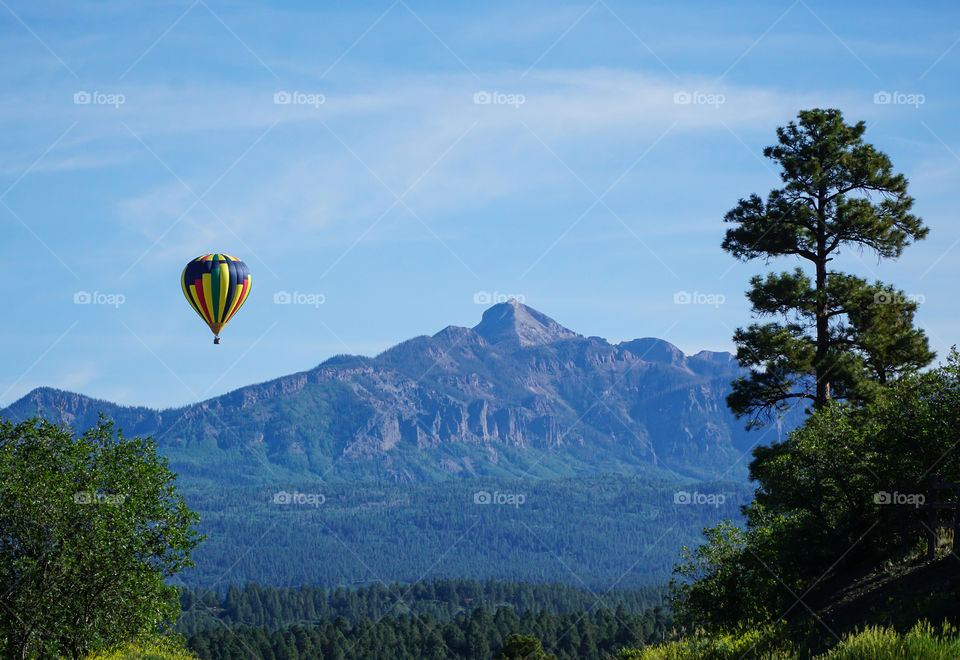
[723,109,934,426]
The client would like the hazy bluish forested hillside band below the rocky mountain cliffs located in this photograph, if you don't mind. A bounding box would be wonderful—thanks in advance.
[177,475,751,589]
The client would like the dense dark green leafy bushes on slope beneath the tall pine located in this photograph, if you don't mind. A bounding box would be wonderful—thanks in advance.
[671,351,960,634]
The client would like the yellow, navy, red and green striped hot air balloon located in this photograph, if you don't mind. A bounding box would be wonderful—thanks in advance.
[180,254,250,344]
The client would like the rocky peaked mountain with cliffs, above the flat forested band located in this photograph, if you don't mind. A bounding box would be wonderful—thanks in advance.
[0,300,798,483]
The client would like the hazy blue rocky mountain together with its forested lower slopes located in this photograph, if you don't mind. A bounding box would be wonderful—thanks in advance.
[0,301,788,588]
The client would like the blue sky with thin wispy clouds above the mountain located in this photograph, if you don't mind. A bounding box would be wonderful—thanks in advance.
[0,0,960,407]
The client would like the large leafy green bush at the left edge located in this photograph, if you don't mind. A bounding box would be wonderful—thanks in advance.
[0,418,201,658]
